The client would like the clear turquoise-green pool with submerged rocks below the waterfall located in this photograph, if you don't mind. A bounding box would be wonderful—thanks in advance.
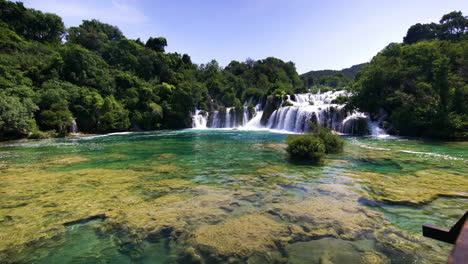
[0,130,468,263]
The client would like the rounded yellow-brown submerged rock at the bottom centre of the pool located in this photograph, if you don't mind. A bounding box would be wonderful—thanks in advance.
[187,215,291,263]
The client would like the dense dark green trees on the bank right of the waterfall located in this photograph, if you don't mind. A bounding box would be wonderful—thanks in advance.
[351,12,468,140]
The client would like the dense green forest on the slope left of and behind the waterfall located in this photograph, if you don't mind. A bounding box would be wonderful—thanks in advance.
[0,0,304,139]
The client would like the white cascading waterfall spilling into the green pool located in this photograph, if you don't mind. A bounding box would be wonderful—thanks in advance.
[192,91,387,137]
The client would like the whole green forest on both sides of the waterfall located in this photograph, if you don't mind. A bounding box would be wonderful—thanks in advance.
[0,0,468,140]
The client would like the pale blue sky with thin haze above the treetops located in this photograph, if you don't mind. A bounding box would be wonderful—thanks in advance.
[23,0,468,73]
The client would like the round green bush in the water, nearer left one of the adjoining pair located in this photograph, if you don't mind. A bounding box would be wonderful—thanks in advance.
[286,134,325,162]
